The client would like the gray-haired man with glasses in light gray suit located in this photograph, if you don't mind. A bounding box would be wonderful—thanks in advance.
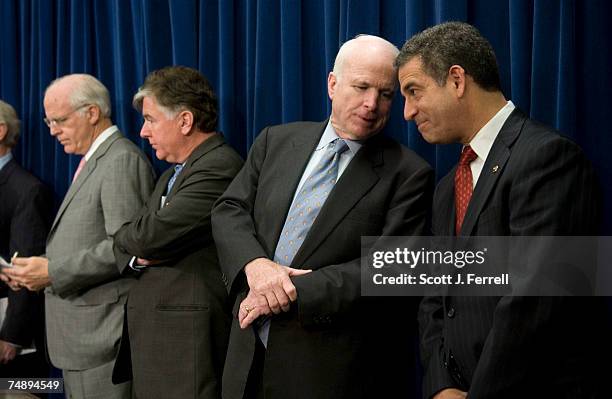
[4,74,154,398]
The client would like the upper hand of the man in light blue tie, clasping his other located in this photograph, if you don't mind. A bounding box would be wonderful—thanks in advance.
[244,258,312,314]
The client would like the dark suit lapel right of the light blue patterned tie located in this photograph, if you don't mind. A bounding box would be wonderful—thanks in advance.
[292,137,383,265]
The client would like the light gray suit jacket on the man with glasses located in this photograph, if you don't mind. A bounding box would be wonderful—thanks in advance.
[46,132,154,370]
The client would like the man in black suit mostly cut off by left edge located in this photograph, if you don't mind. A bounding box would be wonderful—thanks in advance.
[0,101,53,377]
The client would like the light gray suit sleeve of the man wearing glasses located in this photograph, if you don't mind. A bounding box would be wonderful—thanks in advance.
[49,152,153,297]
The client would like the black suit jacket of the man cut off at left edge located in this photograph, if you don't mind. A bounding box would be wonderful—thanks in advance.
[0,160,53,351]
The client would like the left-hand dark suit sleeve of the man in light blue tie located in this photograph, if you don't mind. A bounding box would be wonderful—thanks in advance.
[212,128,268,293]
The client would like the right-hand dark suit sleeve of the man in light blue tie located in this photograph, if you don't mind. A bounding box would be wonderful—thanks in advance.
[293,162,433,326]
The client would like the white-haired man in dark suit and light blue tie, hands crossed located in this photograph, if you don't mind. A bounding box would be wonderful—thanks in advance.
[213,35,433,399]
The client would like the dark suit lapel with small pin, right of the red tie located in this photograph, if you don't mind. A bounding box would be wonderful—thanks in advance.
[460,109,526,236]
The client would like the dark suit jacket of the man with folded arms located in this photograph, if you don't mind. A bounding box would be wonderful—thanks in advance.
[114,135,243,399]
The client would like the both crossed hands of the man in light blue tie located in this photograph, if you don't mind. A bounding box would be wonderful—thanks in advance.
[238,258,312,329]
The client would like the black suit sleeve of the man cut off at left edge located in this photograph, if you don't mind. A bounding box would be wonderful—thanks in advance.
[0,184,52,346]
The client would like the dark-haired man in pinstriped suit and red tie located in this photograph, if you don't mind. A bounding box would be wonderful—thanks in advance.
[396,22,609,399]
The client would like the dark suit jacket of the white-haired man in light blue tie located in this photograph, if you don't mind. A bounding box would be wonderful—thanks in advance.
[213,122,433,399]
